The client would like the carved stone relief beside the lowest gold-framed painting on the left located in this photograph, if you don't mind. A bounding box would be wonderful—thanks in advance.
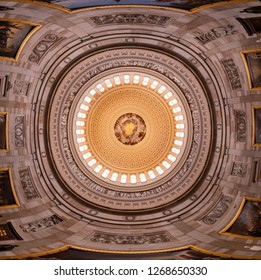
[19,167,40,200]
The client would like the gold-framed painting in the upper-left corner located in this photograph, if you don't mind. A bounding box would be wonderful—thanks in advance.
[0,20,35,60]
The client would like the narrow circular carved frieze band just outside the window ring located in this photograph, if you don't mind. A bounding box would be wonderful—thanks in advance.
[61,60,200,199]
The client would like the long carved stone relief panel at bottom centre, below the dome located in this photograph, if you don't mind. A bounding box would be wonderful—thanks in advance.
[91,232,170,245]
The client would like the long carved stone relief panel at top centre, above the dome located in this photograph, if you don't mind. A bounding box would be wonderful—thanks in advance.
[90,14,170,25]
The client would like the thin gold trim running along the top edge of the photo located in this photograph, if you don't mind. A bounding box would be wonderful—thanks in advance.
[5,0,255,14]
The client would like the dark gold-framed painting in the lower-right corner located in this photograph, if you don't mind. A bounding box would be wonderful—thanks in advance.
[226,199,261,237]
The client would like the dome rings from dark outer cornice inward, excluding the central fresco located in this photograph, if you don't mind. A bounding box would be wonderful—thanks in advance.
[48,48,212,211]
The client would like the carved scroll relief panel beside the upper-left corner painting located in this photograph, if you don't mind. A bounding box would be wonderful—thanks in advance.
[29,34,62,63]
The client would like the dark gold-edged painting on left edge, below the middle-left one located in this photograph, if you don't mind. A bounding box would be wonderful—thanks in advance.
[0,168,17,208]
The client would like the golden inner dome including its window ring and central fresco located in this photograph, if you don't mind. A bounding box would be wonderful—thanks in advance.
[73,72,188,186]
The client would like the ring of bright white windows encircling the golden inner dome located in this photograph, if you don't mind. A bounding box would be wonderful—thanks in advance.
[74,73,187,185]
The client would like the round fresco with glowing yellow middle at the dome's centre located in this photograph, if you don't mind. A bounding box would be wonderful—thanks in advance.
[114,113,146,145]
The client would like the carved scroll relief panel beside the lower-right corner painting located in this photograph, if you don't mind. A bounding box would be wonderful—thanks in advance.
[202,195,232,225]
